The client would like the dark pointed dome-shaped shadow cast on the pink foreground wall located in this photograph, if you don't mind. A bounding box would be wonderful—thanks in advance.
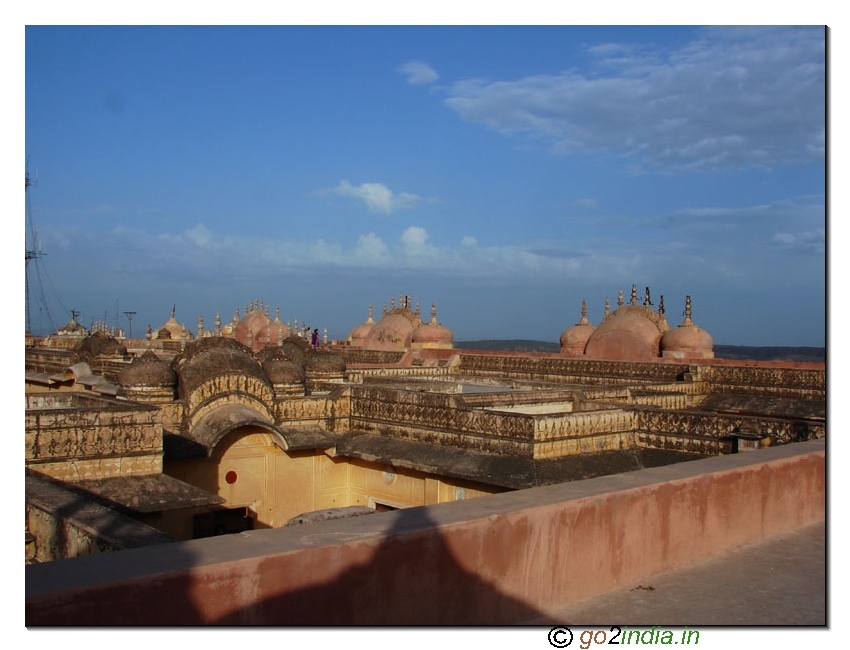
[211,506,545,626]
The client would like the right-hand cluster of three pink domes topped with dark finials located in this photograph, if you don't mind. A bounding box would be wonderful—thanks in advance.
[560,285,714,361]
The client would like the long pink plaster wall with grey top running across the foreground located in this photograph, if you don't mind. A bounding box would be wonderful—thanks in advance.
[26,440,826,626]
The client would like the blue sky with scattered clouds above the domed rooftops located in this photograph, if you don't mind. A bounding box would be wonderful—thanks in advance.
[24,21,827,346]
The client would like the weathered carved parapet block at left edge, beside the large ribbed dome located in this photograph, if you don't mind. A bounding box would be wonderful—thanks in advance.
[24,393,162,481]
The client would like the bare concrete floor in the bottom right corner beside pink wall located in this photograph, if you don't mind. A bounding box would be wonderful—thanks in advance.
[528,522,827,627]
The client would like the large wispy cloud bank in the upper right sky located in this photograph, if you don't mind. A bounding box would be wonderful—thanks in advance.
[445,27,825,170]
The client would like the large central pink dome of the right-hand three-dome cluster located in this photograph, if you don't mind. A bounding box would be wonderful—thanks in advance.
[585,304,670,361]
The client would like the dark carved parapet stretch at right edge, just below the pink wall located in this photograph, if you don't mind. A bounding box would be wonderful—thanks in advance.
[691,365,826,400]
